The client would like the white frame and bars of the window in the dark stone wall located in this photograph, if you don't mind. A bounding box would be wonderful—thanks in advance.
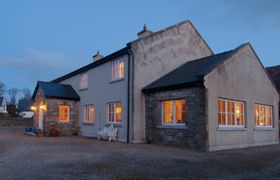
[161,98,187,126]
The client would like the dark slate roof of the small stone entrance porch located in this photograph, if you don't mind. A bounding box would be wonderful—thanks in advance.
[32,81,80,100]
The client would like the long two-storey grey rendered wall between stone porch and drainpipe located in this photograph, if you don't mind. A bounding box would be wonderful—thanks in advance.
[61,56,128,142]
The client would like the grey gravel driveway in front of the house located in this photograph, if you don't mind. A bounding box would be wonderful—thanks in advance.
[0,128,280,179]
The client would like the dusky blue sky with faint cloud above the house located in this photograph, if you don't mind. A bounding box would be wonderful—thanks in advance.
[0,0,280,95]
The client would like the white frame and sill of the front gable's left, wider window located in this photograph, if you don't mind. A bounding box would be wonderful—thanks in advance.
[218,98,246,128]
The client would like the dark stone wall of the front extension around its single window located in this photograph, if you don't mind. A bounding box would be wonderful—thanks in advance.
[146,87,207,150]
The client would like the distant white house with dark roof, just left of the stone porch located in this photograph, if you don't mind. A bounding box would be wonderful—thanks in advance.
[17,99,34,118]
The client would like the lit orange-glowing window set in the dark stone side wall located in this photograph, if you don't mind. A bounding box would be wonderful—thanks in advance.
[162,99,186,126]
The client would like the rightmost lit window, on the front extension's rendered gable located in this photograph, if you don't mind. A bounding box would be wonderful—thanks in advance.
[255,104,272,127]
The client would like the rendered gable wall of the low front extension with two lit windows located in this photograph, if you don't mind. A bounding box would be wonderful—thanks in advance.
[205,45,279,151]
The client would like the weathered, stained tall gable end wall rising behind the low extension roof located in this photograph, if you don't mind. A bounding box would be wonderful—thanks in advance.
[131,21,212,143]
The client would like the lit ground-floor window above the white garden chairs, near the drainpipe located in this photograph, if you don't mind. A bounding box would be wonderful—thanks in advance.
[108,102,122,123]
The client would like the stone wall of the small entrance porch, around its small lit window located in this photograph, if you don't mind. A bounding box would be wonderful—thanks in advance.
[43,99,79,136]
